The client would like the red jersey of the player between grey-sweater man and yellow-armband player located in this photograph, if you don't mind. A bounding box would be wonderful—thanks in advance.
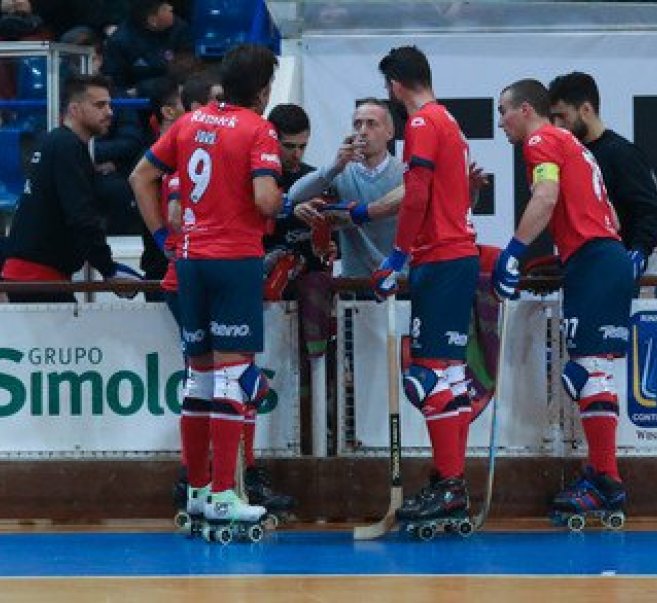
[401,102,477,265]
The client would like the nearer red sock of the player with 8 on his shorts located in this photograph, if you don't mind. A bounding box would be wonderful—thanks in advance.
[422,389,465,479]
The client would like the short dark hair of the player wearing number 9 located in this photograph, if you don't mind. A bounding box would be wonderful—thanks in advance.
[220,44,278,107]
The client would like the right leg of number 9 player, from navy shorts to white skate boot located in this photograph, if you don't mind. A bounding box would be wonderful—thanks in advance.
[204,259,268,521]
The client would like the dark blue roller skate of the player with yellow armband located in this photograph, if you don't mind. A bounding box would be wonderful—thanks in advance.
[550,467,626,532]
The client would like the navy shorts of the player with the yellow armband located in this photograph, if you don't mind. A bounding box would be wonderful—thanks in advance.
[562,239,634,357]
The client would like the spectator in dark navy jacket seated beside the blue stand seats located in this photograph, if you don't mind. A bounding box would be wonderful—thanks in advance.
[103,0,195,93]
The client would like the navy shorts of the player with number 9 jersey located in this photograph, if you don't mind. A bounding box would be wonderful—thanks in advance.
[176,258,263,356]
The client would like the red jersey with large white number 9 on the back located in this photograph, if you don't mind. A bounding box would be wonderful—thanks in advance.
[147,103,281,259]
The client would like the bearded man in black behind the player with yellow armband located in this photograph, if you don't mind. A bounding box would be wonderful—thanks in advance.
[549,71,657,278]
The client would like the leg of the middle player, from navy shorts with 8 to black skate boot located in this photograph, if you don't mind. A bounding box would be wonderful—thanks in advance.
[399,257,478,519]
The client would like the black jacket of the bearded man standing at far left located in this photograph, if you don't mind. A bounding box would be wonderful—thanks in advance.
[7,126,113,277]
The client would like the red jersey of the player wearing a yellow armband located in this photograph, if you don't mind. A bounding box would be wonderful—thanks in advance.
[523,124,620,262]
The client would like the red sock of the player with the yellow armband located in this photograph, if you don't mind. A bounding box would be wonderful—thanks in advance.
[579,394,621,481]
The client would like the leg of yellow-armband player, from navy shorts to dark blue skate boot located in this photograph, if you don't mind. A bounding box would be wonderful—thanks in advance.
[554,241,633,512]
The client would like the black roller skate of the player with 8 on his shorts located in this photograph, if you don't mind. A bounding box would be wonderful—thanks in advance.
[396,474,473,540]
